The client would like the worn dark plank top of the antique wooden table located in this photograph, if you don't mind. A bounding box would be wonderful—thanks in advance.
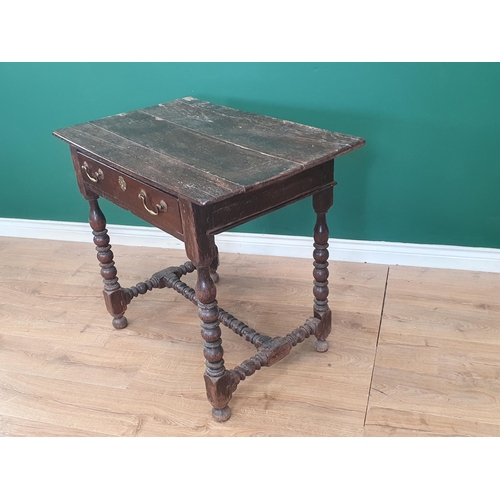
[54,97,365,205]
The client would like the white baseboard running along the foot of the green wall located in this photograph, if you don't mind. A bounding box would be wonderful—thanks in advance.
[0,218,500,273]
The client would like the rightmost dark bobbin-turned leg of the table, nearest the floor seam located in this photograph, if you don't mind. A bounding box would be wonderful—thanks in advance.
[313,187,333,352]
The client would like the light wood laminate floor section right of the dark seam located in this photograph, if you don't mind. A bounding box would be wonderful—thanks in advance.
[366,267,500,436]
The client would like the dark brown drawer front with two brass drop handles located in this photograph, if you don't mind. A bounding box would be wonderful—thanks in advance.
[76,152,183,239]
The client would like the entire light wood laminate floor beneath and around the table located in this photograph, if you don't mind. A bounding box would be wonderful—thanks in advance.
[0,235,500,436]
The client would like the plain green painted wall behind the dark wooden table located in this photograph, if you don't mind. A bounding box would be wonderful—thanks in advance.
[0,63,500,248]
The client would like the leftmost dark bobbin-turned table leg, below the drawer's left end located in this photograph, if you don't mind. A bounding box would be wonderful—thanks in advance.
[88,197,127,329]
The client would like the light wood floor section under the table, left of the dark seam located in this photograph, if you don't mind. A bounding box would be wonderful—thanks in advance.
[0,238,387,436]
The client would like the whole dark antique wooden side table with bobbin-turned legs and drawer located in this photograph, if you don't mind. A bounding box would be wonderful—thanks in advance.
[54,97,365,422]
